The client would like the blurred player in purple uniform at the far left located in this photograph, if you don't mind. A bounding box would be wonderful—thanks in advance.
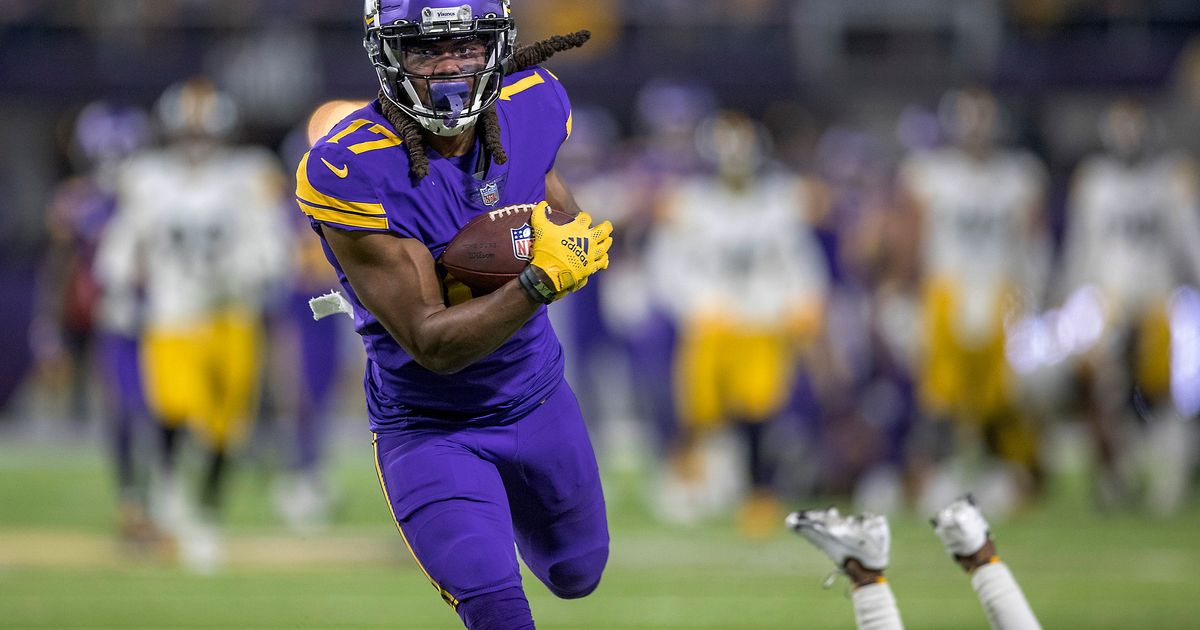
[31,102,152,542]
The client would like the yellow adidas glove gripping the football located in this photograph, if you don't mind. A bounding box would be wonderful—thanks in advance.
[518,202,612,302]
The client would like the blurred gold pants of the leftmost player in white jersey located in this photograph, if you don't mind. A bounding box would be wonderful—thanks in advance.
[142,311,262,449]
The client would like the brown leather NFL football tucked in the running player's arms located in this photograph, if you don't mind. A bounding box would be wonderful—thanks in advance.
[438,204,575,295]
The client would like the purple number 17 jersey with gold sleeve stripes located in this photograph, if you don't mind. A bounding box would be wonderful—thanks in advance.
[296,68,570,432]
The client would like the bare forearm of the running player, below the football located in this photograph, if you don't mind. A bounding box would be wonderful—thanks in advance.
[377,276,540,374]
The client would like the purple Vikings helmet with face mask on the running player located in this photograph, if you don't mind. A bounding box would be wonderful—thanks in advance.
[362,0,516,136]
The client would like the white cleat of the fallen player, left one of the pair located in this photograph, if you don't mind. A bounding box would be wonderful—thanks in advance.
[786,508,892,571]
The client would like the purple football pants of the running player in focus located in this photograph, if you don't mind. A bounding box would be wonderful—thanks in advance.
[376,382,608,624]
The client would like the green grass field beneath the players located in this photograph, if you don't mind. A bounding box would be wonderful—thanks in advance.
[0,434,1200,629]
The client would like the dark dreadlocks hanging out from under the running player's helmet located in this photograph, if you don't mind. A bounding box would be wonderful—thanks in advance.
[379,30,592,181]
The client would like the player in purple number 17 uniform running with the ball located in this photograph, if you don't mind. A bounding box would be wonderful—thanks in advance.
[296,0,612,630]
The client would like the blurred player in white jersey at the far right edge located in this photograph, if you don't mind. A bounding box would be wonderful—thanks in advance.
[1061,100,1200,512]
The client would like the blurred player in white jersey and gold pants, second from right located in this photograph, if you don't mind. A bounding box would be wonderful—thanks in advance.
[899,89,1048,510]
